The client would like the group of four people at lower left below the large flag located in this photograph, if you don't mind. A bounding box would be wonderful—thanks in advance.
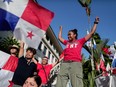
[9,41,59,87]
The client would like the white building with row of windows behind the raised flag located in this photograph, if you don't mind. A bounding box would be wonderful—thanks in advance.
[36,27,63,64]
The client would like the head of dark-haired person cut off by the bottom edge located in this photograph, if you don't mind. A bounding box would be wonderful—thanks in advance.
[23,76,42,87]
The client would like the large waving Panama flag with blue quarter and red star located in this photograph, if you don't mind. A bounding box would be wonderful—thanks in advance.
[0,0,54,48]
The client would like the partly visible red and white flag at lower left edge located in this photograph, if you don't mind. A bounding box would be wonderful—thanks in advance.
[0,51,18,87]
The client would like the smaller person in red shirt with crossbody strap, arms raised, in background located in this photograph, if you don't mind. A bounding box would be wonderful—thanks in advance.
[33,57,59,87]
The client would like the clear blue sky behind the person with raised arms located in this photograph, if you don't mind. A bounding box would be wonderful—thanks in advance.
[38,0,116,57]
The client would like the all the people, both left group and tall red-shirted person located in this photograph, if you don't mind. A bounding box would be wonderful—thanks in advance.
[0,17,99,87]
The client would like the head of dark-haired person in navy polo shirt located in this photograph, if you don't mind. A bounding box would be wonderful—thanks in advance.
[25,47,36,59]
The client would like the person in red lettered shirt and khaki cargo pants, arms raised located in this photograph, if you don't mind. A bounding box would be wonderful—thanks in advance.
[56,17,99,87]
